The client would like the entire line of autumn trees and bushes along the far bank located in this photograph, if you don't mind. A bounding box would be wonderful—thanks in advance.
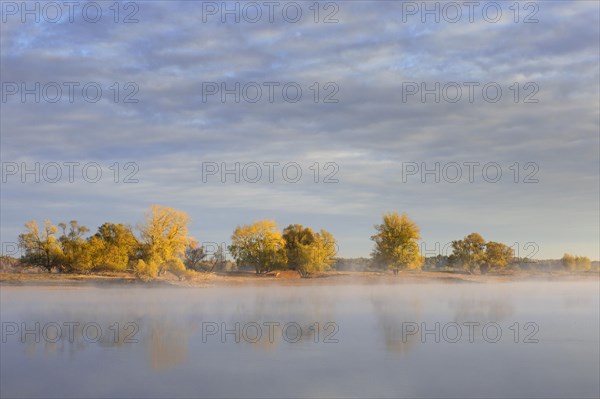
[11,205,592,278]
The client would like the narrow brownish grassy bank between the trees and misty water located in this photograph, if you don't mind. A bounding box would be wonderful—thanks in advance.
[0,271,600,288]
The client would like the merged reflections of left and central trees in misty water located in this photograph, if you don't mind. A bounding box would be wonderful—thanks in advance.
[9,287,339,370]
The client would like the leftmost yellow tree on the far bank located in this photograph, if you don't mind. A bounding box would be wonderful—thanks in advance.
[19,220,62,273]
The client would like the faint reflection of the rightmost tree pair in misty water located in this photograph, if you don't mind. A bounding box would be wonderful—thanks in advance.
[448,297,514,323]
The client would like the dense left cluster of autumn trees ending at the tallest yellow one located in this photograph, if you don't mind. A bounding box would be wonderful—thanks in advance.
[19,205,193,277]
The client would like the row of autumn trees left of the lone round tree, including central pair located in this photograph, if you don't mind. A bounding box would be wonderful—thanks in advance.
[19,205,336,277]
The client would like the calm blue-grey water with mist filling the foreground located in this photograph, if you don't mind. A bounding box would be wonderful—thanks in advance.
[0,281,600,398]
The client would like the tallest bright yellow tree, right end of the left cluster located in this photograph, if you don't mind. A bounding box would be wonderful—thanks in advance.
[137,205,192,276]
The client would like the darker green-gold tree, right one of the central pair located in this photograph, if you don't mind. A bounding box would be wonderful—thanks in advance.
[283,224,336,277]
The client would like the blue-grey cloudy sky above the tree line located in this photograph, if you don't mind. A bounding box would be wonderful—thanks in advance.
[0,1,600,260]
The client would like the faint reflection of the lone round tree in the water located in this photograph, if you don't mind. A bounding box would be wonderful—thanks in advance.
[370,293,422,354]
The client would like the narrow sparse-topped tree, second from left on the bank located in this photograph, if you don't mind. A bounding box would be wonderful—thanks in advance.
[58,220,92,273]
